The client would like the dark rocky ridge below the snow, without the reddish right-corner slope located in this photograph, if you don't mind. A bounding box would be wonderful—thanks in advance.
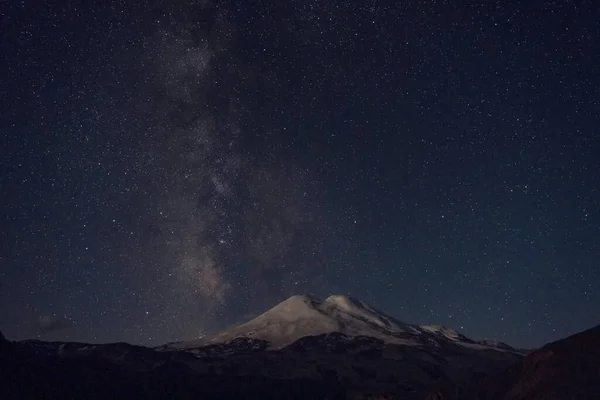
[0,333,520,399]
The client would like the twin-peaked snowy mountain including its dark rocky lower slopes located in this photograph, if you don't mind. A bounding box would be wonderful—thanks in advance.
[151,295,522,400]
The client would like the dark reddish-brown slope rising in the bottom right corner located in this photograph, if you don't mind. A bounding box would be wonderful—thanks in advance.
[429,325,600,400]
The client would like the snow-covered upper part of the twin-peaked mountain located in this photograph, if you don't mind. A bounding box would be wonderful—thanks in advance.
[165,295,516,350]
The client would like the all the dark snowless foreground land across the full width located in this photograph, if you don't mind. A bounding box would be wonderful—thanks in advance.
[0,326,600,400]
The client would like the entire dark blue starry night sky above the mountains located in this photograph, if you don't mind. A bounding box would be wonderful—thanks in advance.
[0,0,600,347]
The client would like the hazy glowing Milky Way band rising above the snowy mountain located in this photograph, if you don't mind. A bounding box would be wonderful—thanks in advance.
[130,6,326,335]
